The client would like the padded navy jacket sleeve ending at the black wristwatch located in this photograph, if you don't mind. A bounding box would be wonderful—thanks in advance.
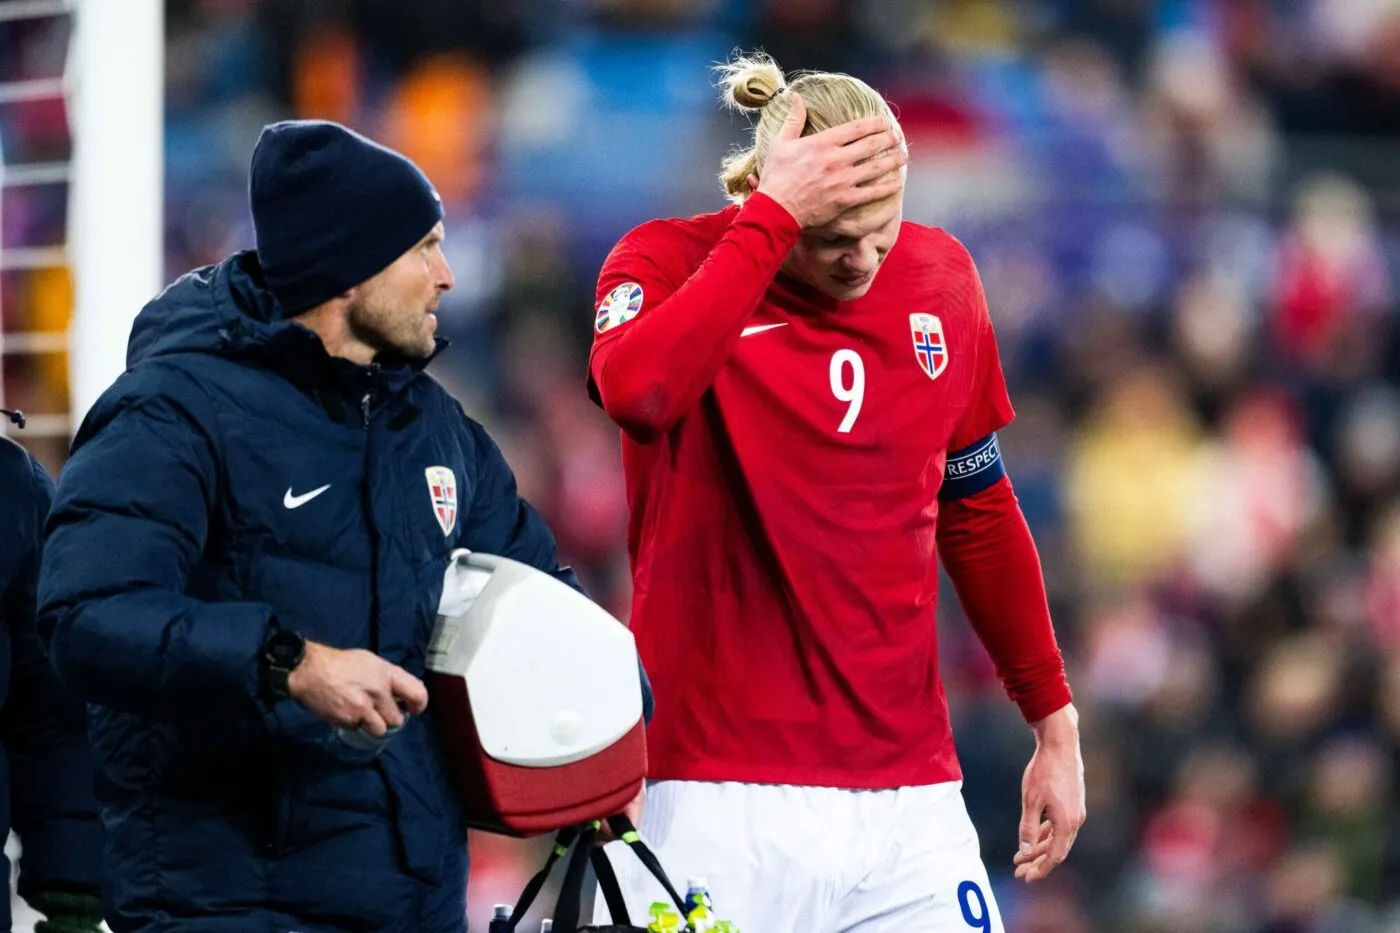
[39,387,272,721]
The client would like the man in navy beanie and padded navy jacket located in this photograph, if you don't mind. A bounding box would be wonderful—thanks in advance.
[39,122,645,933]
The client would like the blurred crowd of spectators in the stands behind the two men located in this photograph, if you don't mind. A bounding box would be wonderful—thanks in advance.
[0,0,1400,933]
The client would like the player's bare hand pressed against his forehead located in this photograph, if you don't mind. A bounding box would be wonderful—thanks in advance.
[749,91,909,230]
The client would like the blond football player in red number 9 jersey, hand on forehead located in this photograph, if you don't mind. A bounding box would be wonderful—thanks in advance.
[589,56,1085,933]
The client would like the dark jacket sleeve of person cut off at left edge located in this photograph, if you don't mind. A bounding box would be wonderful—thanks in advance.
[0,461,102,899]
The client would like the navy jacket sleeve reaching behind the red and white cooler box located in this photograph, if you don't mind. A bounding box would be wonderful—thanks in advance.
[462,413,652,723]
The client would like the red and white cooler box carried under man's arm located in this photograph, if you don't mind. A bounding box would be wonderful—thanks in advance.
[427,551,647,836]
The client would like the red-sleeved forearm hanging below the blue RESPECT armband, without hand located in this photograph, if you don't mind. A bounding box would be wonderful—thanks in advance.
[938,479,1071,714]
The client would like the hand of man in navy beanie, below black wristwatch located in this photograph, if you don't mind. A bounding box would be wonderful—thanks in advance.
[287,642,428,735]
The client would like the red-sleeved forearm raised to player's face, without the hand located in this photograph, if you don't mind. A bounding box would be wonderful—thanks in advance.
[592,195,801,440]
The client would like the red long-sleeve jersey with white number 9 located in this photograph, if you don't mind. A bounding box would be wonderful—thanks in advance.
[589,195,1070,787]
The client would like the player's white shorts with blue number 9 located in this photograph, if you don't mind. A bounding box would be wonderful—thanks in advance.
[594,780,1005,933]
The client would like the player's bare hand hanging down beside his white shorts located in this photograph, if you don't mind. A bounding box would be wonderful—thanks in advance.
[1014,705,1085,881]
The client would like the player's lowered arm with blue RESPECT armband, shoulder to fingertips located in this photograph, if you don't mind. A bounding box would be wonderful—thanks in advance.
[938,245,1085,881]
